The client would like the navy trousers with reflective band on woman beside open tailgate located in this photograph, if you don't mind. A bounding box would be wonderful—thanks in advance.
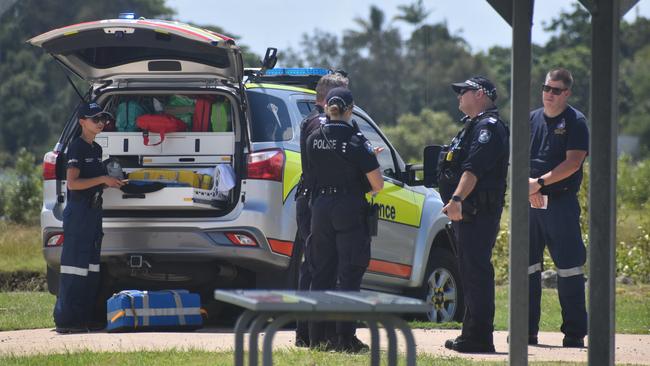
[53,200,103,327]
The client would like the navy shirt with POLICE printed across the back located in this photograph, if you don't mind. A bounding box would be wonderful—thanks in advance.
[307,121,379,194]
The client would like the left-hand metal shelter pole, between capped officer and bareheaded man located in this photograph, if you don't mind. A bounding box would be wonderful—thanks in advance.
[508,0,534,365]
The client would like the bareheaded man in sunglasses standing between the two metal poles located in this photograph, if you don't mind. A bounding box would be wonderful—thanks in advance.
[528,68,589,347]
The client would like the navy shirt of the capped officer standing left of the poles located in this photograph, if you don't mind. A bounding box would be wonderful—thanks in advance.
[460,108,510,192]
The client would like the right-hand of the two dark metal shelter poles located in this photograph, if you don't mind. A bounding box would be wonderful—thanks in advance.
[589,0,620,365]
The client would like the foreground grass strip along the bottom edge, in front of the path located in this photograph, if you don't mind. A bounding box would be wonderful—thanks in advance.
[0,350,584,366]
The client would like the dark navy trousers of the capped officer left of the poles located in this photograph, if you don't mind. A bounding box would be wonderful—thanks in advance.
[453,203,503,343]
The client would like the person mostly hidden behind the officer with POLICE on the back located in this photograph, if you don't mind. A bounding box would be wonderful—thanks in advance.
[292,72,348,347]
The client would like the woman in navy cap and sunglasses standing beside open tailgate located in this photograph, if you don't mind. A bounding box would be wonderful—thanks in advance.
[54,103,124,333]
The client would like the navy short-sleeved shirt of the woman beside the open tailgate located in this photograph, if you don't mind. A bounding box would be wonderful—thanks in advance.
[67,136,107,199]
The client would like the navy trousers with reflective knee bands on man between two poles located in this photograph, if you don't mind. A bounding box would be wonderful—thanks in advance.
[528,193,587,338]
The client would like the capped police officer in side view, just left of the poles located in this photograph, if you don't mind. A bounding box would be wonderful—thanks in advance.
[439,76,509,352]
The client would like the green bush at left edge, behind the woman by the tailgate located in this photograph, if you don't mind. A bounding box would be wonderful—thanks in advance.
[2,148,43,224]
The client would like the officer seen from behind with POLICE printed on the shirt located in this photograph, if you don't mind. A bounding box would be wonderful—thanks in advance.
[307,88,384,352]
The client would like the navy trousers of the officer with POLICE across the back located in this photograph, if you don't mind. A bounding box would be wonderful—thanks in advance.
[307,194,370,345]
